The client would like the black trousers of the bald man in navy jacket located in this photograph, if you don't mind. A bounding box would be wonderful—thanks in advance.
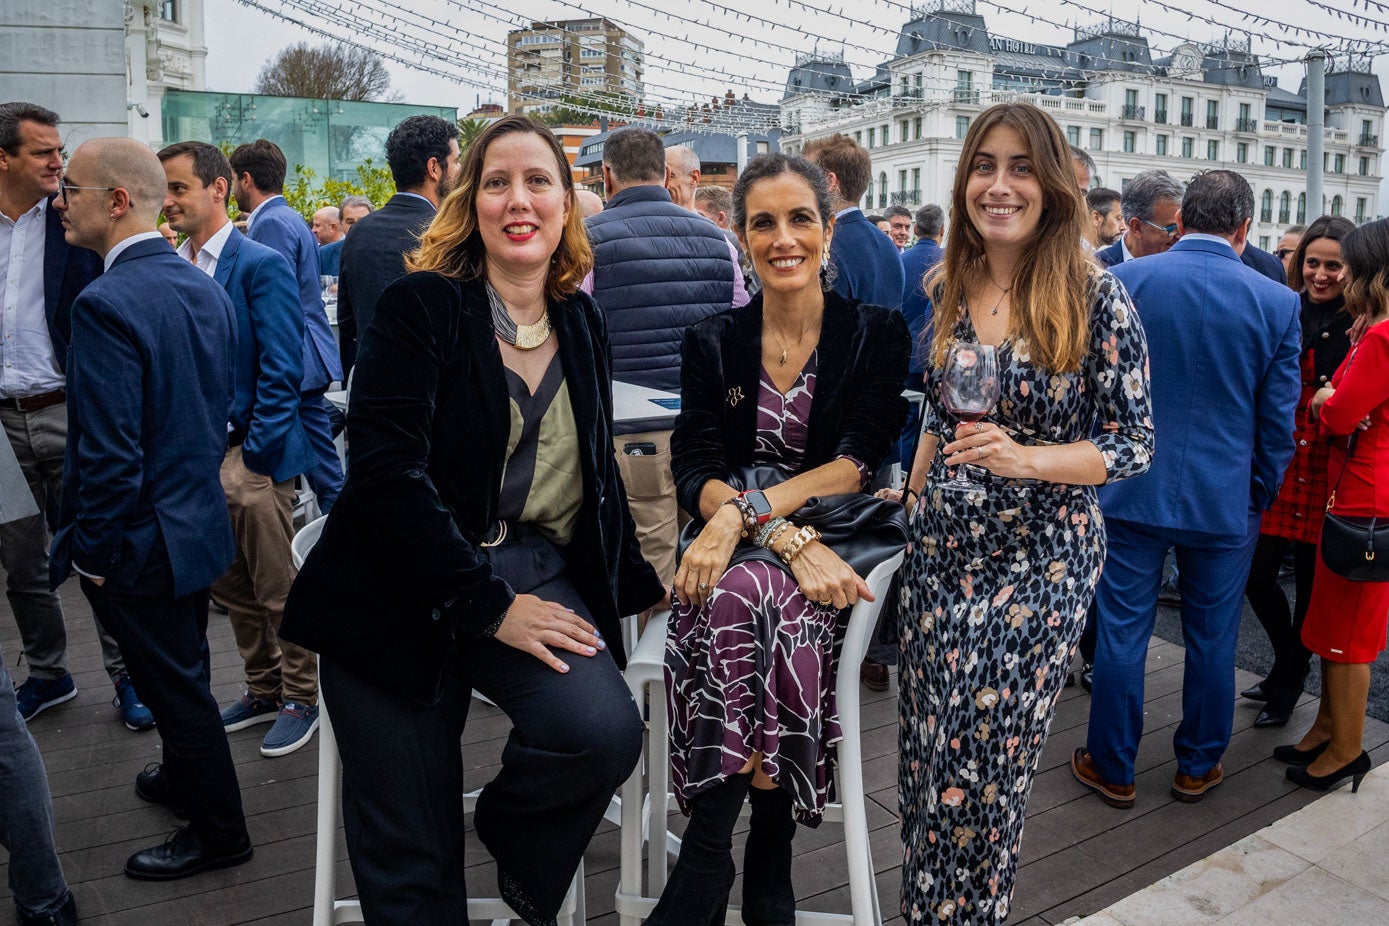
[82,541,250,851]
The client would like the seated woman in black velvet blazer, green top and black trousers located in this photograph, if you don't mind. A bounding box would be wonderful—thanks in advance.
[282,117,663,926]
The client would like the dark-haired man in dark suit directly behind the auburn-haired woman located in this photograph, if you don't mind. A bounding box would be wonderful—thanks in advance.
[338,115,461,383]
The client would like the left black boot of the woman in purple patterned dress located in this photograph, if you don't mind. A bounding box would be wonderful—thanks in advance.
[646,773,753,926]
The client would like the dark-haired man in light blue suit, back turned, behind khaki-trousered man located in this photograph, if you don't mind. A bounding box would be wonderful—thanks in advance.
[231,139,343,514]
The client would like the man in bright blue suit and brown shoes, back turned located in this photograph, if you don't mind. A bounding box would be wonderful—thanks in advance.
[1071,171,1301,807]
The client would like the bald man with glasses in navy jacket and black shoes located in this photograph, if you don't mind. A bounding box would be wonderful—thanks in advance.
[51,139,251,880]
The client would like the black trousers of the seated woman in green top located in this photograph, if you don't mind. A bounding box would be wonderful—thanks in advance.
[318,527,643,926]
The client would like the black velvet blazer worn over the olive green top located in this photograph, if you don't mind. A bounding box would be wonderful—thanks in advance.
[281,272,663,702]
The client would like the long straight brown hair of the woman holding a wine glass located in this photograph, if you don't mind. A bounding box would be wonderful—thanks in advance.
[925,103,1099,373]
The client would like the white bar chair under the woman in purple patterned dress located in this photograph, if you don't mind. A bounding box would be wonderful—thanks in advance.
[615,553,904,926]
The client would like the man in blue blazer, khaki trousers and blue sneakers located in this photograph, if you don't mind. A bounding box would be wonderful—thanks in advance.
[158,142,318,757]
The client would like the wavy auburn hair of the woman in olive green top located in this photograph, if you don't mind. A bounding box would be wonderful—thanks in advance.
[406,115,593,298]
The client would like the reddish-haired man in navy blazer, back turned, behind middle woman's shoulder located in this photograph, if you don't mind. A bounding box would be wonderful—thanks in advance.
[804,135,906,308]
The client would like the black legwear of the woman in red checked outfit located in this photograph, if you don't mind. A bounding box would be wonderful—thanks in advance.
[1245,533,1317,708]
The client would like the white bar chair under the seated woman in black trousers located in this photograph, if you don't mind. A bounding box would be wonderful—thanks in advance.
[290,516,586,926]
